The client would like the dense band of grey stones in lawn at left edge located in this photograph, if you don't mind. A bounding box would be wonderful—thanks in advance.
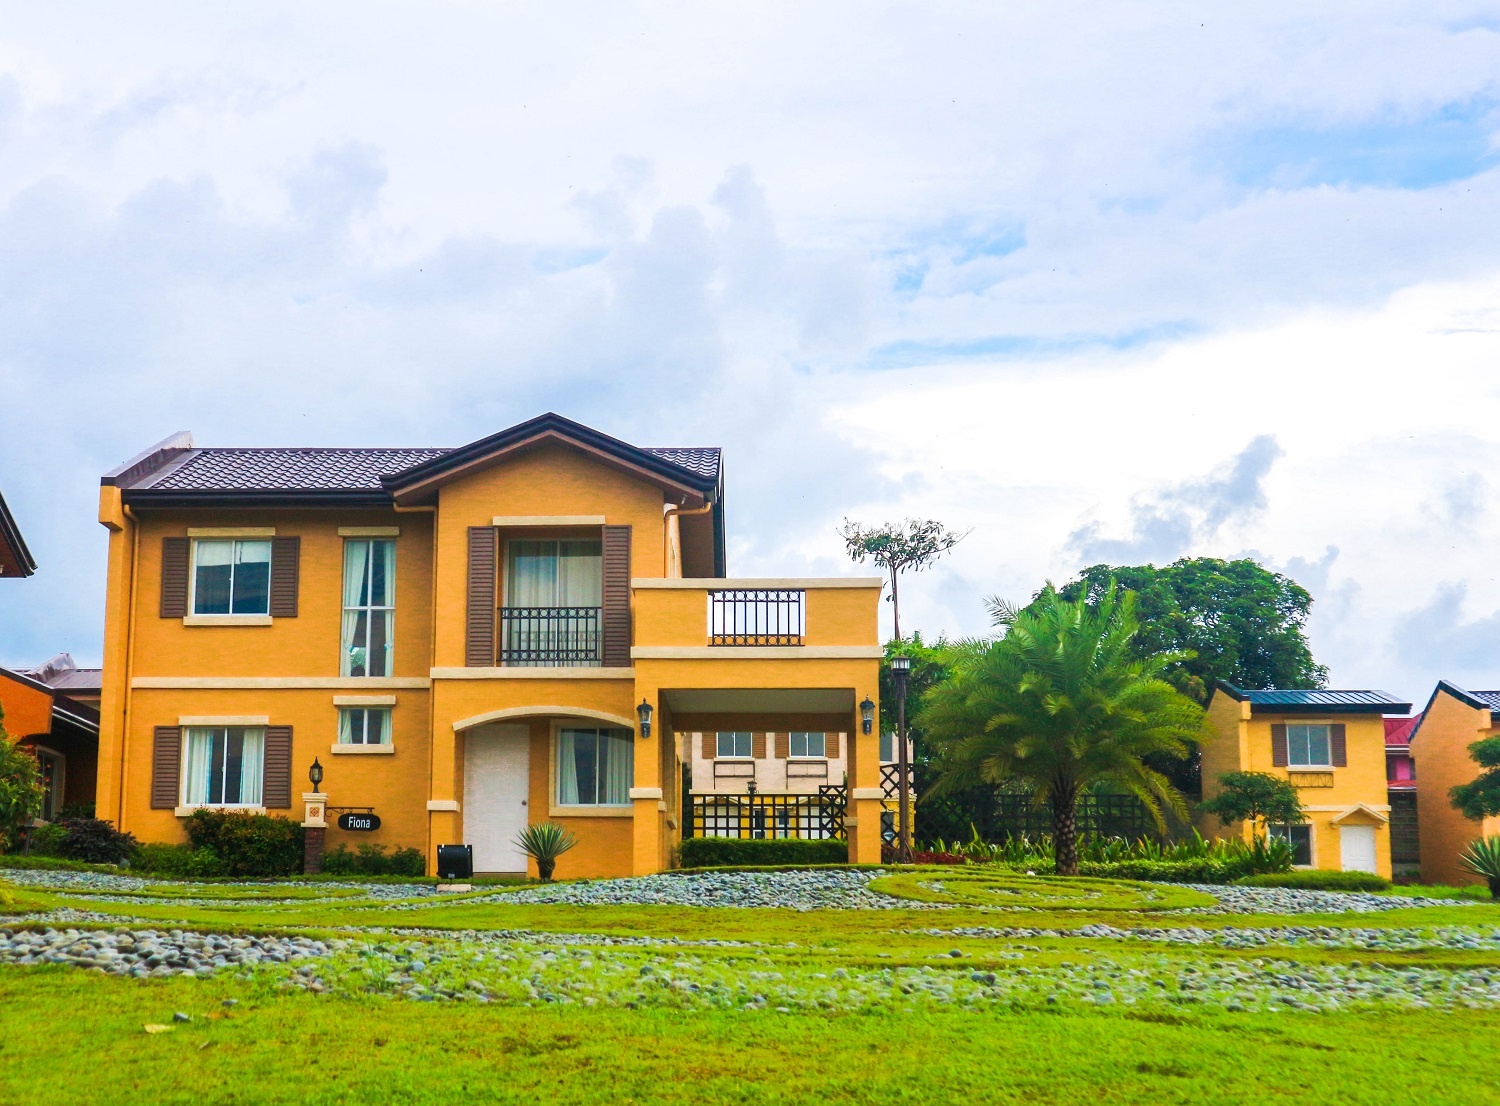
[0,926,331,978]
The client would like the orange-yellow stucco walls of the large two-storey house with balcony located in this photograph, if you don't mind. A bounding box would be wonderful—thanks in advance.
[98,435,881,876]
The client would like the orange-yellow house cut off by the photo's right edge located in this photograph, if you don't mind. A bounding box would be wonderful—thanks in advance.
[1412,680,1500,884]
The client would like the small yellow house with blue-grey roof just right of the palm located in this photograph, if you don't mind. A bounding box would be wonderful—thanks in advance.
[1200,680,1421,879]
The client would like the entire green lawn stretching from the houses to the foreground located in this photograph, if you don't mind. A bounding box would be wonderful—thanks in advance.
[0,872,1500,1106]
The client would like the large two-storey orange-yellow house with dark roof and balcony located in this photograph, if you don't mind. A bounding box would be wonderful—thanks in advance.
[98,414,884,876]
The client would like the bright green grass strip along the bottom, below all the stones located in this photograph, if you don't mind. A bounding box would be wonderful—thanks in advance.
[0,968,1500,1106]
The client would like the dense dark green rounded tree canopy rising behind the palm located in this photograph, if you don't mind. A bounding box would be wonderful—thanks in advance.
[1034,557,1328,702]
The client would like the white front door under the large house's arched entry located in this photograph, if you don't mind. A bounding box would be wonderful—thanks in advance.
[464,725,531,872]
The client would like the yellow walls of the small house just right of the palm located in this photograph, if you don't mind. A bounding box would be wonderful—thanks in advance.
[1199,690,1391,879]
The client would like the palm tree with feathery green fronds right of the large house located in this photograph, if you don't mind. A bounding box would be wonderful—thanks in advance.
[918,584,1203,875]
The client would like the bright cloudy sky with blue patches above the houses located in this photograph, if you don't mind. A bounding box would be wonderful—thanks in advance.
[0,0,1500,705]
